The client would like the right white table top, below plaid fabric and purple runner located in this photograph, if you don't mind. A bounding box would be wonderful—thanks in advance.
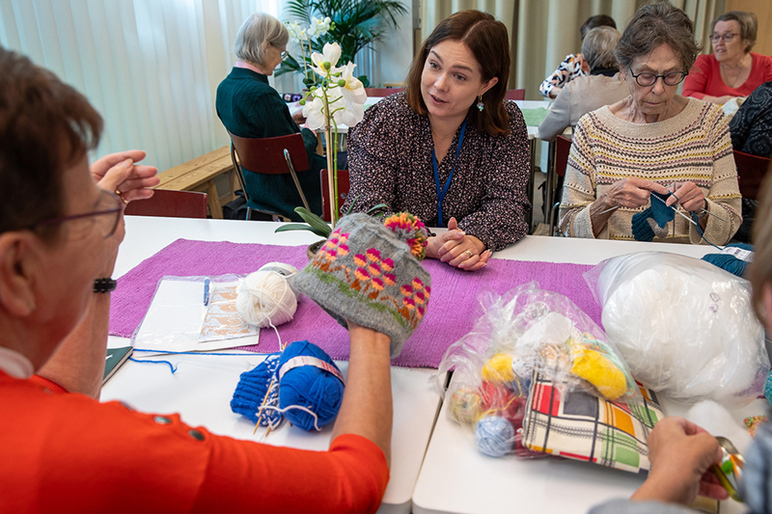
[413,236,758,514]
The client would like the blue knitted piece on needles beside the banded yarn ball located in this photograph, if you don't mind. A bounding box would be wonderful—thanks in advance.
[231,353,281,426]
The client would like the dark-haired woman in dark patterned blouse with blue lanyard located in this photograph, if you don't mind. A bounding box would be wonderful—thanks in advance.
[344,10,530,270]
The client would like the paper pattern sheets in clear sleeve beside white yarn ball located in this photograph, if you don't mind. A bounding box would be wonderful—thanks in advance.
[132,275,260,352]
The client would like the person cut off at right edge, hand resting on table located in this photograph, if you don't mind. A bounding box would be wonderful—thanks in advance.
[590,164,772,514]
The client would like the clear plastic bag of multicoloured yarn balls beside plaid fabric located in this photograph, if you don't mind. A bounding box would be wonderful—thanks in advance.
[438,282,640,457]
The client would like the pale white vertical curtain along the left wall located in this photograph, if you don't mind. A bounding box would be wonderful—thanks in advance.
[0,0,286,170]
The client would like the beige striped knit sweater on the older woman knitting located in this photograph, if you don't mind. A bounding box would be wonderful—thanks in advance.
[560,98,742,245]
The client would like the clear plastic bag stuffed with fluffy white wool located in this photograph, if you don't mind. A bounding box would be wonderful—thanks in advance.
[585,252,769,404]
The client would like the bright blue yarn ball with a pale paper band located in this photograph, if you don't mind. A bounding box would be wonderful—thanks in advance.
[279,341,343,431]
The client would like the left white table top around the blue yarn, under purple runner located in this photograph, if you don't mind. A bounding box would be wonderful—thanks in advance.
[102,216,440,513]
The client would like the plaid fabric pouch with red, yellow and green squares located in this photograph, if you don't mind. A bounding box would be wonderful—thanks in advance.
[522,372,665,473]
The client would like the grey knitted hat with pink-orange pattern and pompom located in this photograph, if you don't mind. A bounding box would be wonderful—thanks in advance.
[290,213,431,357]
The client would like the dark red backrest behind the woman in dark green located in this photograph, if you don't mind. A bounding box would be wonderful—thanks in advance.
[228,132,310,175]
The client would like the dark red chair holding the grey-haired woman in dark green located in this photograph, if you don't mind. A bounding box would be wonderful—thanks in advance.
[228,132,311,220]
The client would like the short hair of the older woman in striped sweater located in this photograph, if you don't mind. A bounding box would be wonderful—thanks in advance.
[616,2,700,73]
